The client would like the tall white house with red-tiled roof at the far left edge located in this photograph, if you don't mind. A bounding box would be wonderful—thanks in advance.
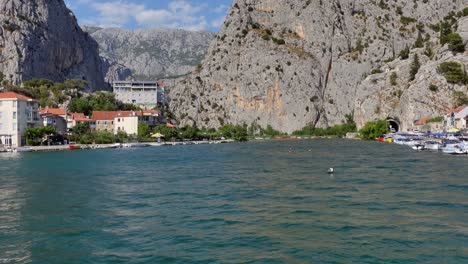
[0,92,41,147]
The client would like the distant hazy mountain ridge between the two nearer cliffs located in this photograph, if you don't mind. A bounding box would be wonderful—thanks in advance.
[84,27,215,81]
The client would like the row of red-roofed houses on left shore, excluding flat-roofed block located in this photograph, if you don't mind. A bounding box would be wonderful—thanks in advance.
[0,92,165,148]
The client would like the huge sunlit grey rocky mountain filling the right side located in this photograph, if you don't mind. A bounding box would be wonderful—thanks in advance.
[170,0,468,132]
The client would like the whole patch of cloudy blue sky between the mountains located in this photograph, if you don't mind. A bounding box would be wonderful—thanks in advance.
[65,0,232,31]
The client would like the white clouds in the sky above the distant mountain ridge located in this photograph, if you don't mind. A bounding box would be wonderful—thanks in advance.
[75,0,221,30]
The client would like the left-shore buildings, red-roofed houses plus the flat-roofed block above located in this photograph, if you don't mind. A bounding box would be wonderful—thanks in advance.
[0,81,167,150]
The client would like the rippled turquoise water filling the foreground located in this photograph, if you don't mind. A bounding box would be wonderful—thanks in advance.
[0,140,468,263]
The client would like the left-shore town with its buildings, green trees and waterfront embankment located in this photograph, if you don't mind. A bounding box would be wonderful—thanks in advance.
[0,80,245,152]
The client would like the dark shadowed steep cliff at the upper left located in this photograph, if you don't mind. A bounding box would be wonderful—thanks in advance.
[0,0,107,90]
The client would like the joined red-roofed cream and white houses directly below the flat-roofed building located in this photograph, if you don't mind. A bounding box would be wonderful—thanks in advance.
[91,110,163,135]
